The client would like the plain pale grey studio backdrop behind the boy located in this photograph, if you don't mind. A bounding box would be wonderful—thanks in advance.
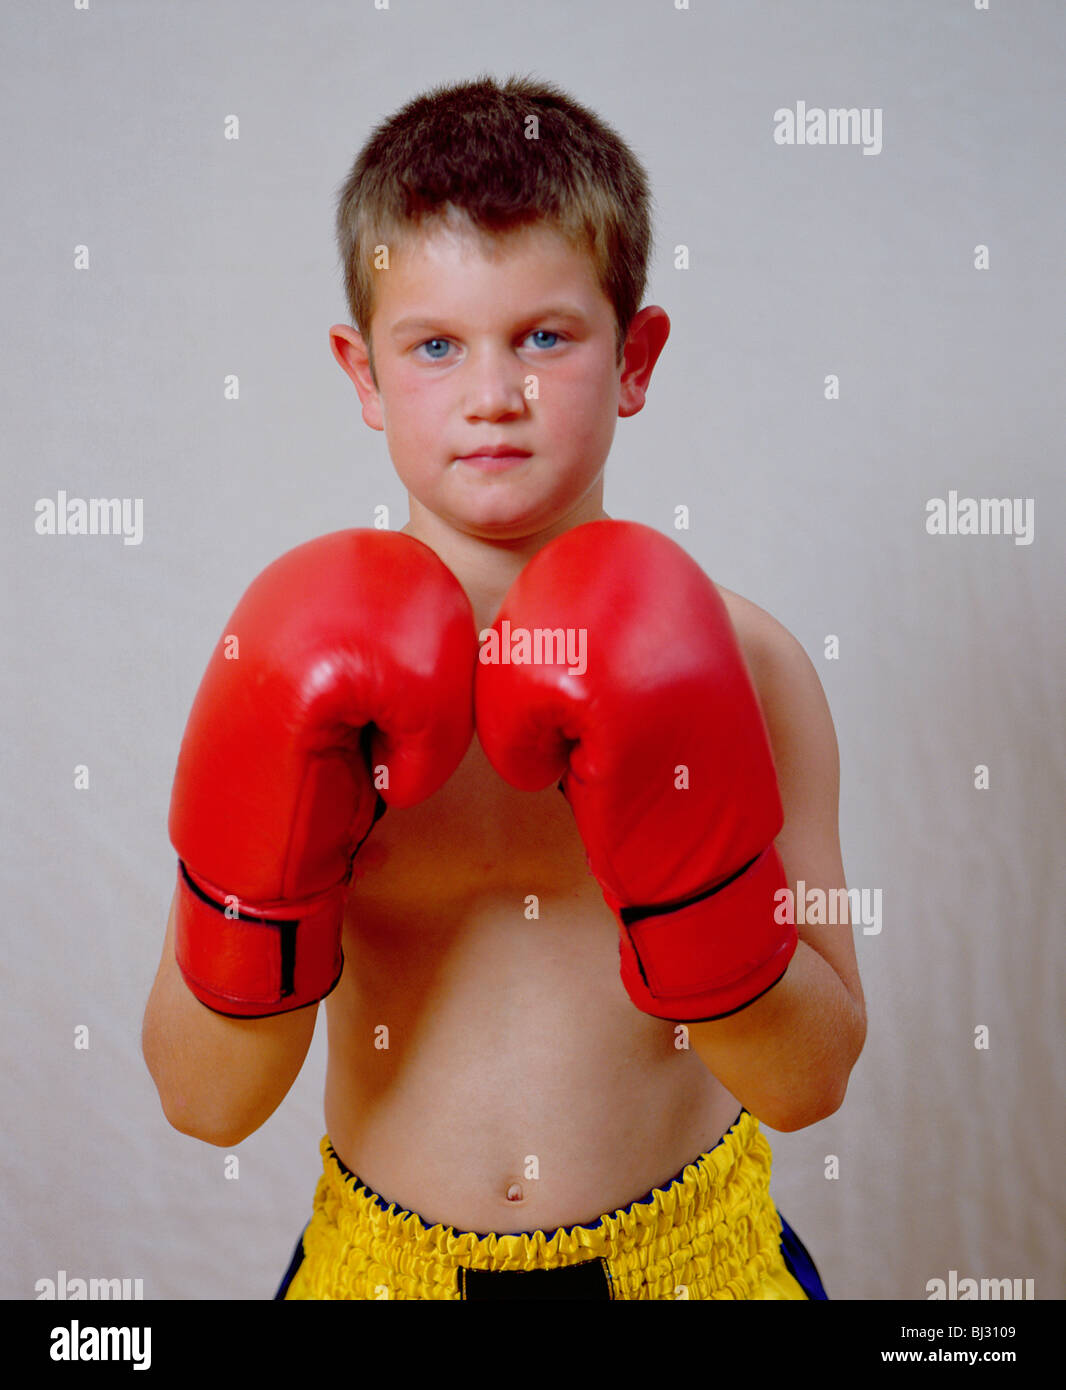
[0,0,1066,1300]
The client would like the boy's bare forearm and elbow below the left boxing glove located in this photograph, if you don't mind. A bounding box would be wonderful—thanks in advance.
[142,901,318,1148]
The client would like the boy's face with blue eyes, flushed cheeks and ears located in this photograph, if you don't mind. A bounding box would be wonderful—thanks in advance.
[332,225,666,539]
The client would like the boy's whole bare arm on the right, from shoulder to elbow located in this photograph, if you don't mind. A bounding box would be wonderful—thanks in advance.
[689,608,866,1130]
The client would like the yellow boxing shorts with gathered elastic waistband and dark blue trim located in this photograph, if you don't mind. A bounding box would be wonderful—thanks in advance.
[277,1111,826,1300]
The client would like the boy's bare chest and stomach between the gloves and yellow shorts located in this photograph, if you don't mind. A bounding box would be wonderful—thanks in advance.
[325,591,751,1233]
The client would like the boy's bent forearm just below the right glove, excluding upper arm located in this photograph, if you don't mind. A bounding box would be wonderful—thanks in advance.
[688,941,866,1130]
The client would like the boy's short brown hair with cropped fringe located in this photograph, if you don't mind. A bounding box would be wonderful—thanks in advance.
[336,76,652,360]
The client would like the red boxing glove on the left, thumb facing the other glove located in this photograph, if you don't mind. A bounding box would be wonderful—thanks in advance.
[170,530,477,1017]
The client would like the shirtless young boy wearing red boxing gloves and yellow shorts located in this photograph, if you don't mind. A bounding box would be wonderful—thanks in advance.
[145,79,866,1300]
